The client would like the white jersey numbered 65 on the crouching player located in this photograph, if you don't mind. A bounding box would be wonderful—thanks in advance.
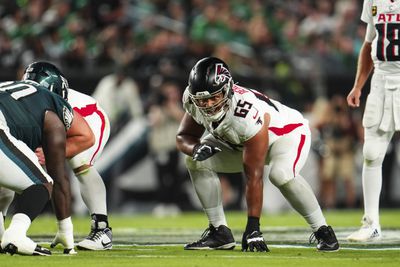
[183,85,308,150]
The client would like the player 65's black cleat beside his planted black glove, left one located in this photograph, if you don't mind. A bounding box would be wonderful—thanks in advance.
[184,225,236,250]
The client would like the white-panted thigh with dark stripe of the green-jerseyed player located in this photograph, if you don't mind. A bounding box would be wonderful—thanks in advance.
[0,131,53,192]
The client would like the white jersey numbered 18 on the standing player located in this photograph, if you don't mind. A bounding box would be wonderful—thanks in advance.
[361,0,400,74]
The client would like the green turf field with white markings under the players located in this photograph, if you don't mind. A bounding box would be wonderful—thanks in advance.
[0,210,400,267]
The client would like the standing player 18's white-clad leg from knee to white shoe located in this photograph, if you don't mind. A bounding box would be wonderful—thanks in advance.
[347,128,393,242]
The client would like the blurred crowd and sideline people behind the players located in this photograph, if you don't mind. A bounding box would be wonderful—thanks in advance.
[0,0,399,215]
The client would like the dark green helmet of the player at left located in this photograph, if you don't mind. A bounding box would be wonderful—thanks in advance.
[22,61,69,100]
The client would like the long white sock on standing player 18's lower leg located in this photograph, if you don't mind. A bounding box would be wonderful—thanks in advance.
[362,163,382,225]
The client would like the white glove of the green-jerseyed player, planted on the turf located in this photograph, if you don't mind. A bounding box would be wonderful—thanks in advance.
[50,217,77,254]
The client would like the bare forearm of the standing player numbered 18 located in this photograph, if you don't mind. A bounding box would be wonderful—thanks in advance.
[353,42,373,91]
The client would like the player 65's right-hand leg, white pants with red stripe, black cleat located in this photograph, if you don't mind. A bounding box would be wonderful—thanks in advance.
[269,128,339,251]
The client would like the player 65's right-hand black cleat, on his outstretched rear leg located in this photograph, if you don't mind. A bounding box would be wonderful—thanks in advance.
[310,225,339,252]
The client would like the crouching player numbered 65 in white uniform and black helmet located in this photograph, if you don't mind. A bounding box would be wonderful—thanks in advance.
[176,57,339,251]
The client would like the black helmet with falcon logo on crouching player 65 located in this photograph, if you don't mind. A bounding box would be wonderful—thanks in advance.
[187,57,233,121]
